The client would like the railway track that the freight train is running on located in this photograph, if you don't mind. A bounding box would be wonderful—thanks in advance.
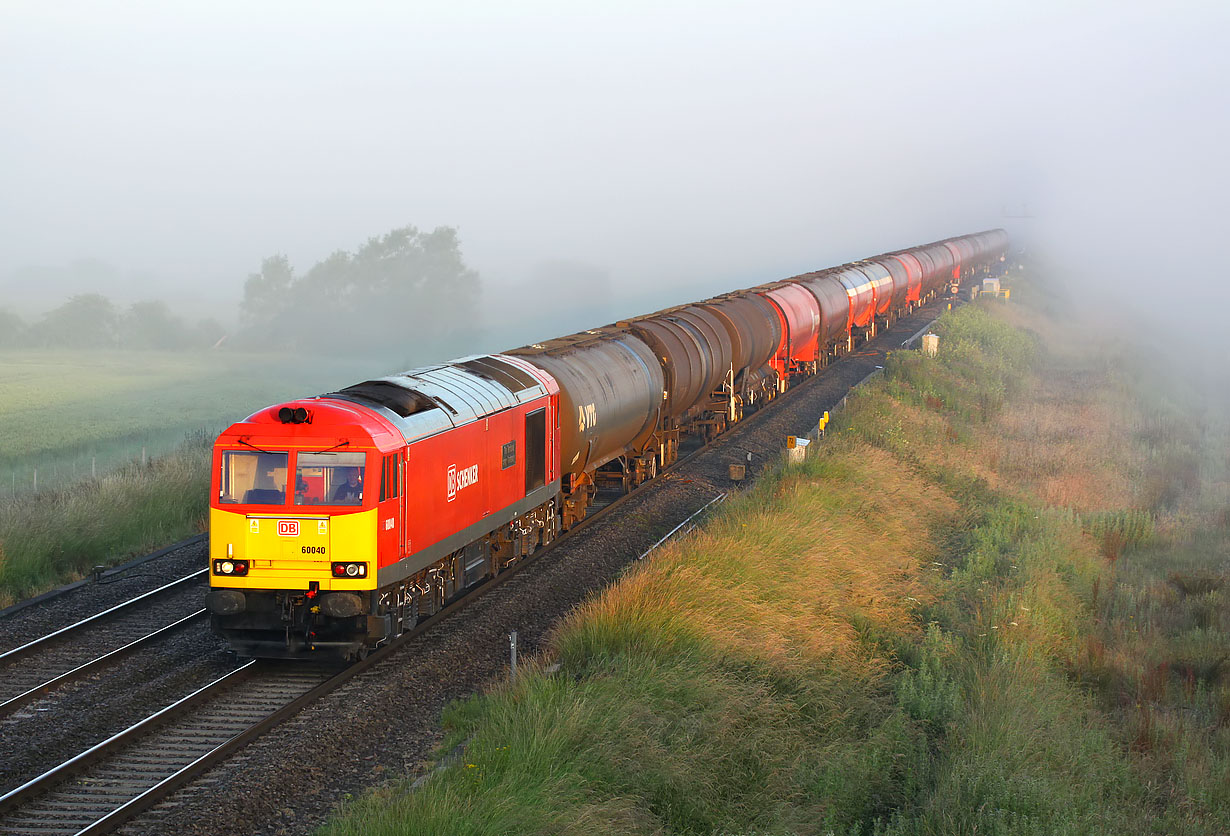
[0,297,954,835]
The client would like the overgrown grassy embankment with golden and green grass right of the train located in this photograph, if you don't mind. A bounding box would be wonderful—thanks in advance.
[325,282,1230,836]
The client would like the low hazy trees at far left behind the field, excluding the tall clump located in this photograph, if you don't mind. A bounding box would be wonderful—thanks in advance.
[0,293,226,350]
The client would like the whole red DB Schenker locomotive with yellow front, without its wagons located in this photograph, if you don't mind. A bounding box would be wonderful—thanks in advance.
[208,357,560,657]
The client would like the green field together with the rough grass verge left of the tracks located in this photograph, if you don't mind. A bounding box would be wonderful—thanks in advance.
[0,352,356,606]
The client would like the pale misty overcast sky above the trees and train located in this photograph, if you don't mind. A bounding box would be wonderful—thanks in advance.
[0,0,1230,329]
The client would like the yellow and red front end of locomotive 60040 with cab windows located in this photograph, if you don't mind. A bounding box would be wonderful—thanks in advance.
[207,401,396,658]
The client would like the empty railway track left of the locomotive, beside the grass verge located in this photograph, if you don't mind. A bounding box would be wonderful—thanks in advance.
[0,569,208,718]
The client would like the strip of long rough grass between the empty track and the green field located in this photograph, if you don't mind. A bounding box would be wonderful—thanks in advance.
[0,435,212,606]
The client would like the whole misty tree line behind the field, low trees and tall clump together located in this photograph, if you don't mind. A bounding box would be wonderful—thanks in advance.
[0,226,480,355]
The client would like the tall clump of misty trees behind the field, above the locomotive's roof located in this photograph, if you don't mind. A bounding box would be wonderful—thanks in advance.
[242,226,478,353]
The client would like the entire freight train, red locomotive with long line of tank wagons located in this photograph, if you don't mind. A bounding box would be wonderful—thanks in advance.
[207,230,1009,659]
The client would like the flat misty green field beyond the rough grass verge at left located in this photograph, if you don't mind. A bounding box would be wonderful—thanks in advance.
[0,350,375,495]
